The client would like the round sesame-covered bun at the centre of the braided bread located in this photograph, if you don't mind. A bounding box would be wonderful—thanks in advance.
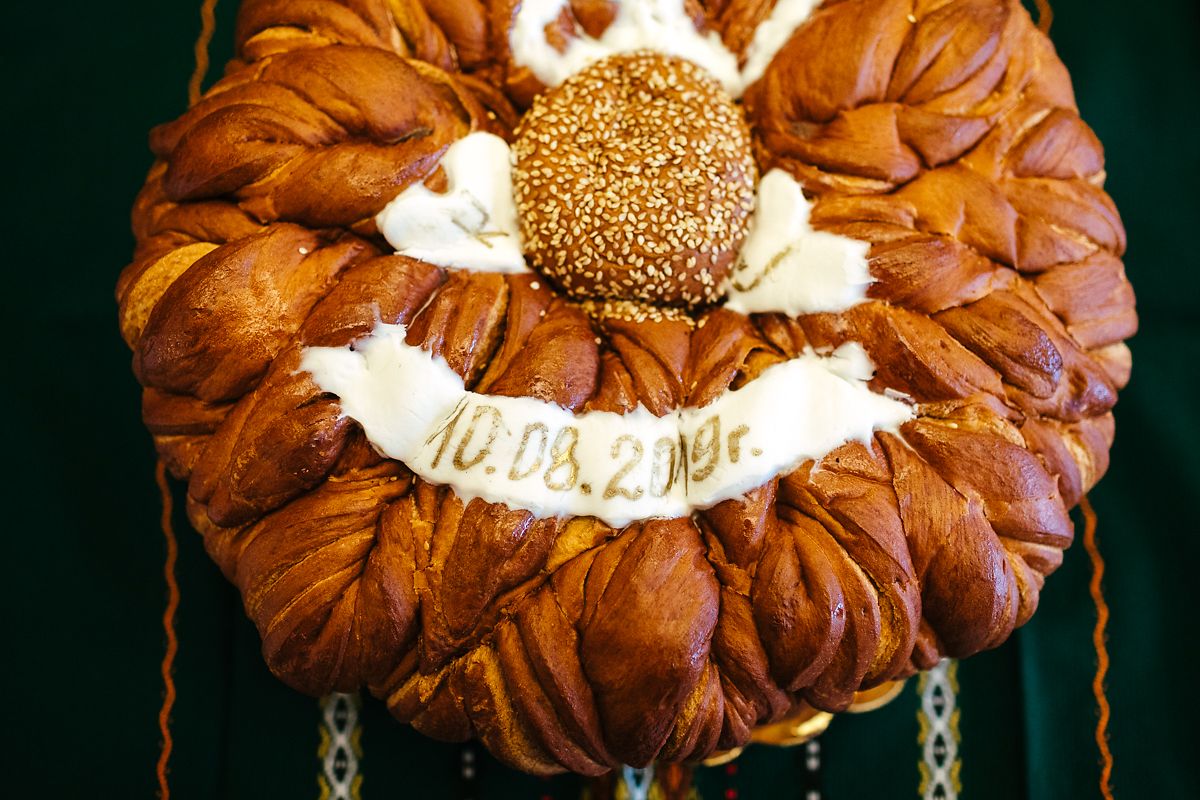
[514,52,757,306]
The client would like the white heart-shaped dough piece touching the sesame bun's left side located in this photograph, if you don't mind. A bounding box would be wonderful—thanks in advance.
[376,132,529,272]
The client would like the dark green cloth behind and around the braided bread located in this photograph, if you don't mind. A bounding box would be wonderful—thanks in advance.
[0,0,1200,800]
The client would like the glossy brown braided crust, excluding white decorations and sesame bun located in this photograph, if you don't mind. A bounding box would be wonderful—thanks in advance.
[118,0,1136,774]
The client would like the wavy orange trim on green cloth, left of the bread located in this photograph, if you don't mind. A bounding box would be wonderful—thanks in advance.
[155,0,217,800]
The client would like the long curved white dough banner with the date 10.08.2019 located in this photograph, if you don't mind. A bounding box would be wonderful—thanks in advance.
[300,323,912,528]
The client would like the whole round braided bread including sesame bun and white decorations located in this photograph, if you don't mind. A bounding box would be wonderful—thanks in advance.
[118,0,1136,774]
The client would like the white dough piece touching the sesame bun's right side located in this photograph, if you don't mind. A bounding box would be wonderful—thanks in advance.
[725,169,874,317]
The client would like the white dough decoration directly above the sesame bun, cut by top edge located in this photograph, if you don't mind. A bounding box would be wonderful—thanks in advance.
[509,0,820,97]
